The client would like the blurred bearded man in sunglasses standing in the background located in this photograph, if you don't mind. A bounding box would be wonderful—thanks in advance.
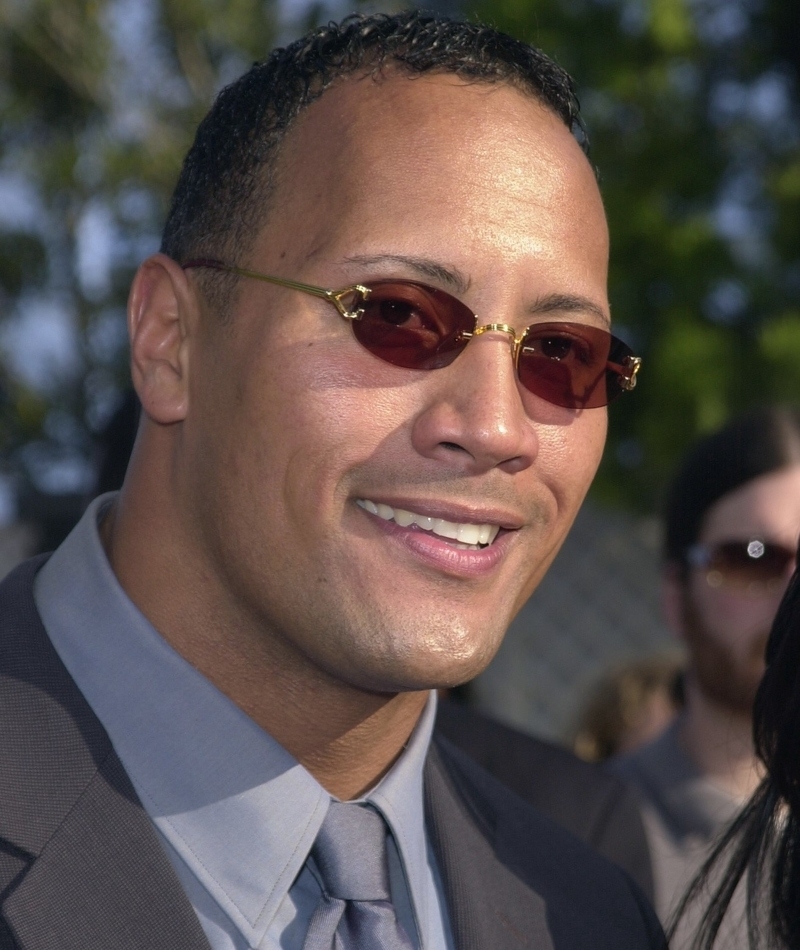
[614,407,800,948]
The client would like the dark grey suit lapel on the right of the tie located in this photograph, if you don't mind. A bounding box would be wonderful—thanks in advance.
[425,744,553,950]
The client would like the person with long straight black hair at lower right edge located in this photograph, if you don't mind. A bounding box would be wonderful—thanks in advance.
[671,573,800,950]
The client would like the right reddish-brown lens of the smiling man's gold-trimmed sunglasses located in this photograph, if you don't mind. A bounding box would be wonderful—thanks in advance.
[518,323,633,409]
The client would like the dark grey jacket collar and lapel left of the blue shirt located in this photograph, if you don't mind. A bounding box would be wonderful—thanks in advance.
[0,561,210,950]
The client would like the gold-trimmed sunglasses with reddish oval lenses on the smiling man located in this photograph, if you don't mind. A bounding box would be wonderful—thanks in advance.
[182,258,642,409]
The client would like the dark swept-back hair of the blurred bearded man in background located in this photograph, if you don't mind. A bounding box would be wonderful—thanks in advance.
[664,406,800,567]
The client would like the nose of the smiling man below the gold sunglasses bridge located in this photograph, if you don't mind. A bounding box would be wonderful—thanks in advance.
[412,329,538,474]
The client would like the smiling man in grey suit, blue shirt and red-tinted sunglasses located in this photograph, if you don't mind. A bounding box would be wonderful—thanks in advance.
[0,13,661,950]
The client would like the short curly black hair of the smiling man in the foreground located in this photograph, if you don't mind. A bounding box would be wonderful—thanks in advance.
[161,11,587,307]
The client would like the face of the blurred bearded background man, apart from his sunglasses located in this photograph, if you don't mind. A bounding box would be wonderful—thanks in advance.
[684,465,800,715]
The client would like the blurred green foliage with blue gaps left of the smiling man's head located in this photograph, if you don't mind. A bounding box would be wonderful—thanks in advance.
[0,0,276,492]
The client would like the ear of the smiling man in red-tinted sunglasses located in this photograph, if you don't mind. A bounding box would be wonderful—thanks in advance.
[128,254,198,425]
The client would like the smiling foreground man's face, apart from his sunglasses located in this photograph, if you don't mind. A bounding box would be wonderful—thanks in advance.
[178,76,608,692]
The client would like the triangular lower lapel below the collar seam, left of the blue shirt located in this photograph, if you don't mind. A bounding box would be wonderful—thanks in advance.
[4,752,209,950]
